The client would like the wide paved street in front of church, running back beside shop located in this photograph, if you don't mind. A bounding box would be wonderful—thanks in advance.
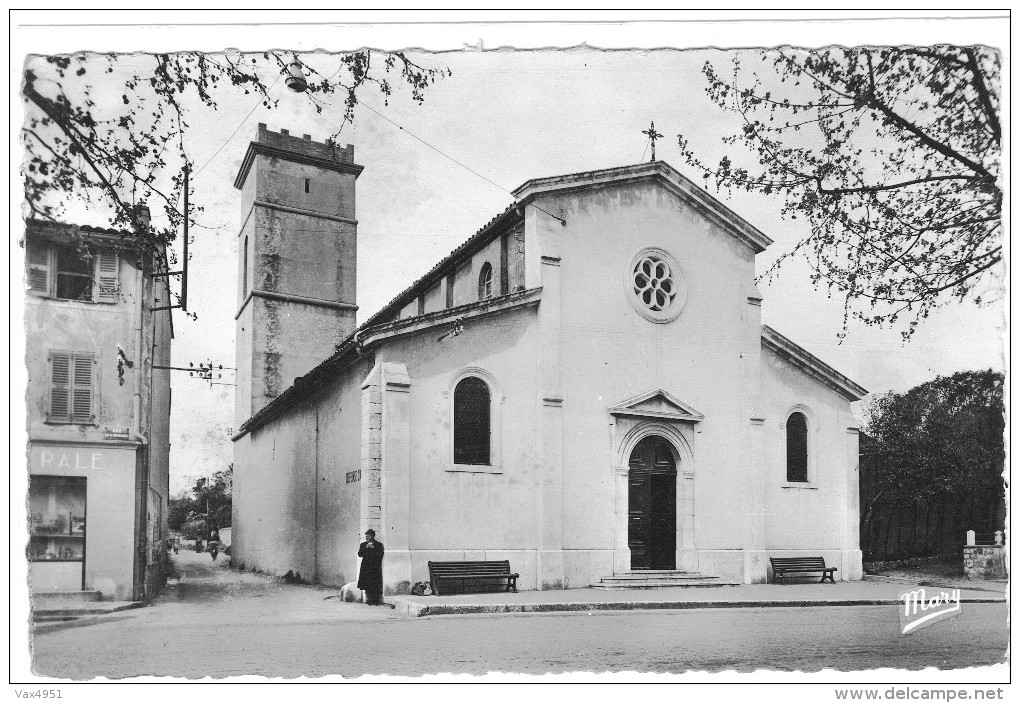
[27,553,1008,680]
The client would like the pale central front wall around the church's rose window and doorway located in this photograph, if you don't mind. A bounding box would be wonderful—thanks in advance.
[528,178,754,586]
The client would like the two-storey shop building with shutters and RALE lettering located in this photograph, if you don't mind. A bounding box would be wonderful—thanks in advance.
[23,220,173,600]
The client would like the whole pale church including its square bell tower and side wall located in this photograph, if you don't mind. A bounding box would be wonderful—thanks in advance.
[232,124,866,593]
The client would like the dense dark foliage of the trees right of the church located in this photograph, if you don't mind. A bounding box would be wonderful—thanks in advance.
[861,370,1006,530]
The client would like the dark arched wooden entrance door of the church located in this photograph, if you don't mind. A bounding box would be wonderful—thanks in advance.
[627,437,676,569]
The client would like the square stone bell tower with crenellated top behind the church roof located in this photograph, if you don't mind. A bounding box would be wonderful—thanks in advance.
[234,123,364,428]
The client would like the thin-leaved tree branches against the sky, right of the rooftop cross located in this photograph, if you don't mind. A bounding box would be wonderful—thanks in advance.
[678,46,1003,339]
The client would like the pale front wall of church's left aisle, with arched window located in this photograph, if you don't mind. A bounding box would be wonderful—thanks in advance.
[371,307,540,588]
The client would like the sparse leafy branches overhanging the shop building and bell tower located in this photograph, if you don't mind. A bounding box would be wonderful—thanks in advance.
[21,50,449,304]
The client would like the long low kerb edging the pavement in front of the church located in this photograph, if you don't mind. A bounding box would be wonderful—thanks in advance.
[390,596,1006,617]
